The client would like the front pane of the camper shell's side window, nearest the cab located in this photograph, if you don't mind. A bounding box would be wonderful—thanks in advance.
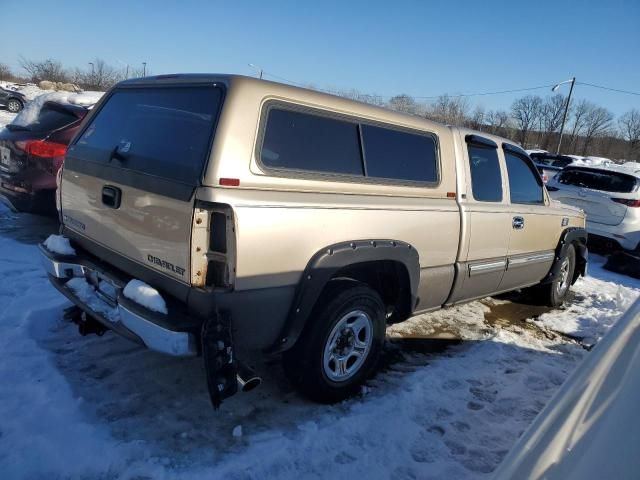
[361,124,438,183]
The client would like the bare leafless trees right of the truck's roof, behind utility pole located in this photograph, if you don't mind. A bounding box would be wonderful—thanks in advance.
[324,87,640,161]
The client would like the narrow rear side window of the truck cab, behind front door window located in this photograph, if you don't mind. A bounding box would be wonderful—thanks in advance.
[468,143,502,202]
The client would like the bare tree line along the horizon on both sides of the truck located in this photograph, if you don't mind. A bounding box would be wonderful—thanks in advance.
[0,57,640,161]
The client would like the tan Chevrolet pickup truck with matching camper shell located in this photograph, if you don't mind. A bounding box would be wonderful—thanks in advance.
[40,75,587,406]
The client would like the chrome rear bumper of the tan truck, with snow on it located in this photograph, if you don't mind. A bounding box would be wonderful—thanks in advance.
[39,245,199,357]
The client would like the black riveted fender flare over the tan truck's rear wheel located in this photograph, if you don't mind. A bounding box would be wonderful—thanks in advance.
[267,240,420,354]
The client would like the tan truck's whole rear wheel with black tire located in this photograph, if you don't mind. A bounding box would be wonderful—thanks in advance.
[283,281,385,403]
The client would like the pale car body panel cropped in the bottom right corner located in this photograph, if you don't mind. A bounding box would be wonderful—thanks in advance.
[492,300,640,480]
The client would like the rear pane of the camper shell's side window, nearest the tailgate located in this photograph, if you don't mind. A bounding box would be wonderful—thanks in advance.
[261,108,364,176]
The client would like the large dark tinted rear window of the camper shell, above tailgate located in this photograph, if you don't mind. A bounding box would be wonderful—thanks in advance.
[76,87,222,185]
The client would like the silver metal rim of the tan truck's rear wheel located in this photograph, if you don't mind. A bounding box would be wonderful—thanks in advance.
[322,310,373,382]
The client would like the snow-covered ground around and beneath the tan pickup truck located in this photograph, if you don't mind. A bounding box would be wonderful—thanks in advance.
[0,203,640,480]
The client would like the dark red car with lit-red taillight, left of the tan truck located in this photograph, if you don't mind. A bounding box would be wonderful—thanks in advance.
[0,101,89,213]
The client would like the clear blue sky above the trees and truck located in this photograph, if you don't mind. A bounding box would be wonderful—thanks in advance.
[5,0,640,114]
